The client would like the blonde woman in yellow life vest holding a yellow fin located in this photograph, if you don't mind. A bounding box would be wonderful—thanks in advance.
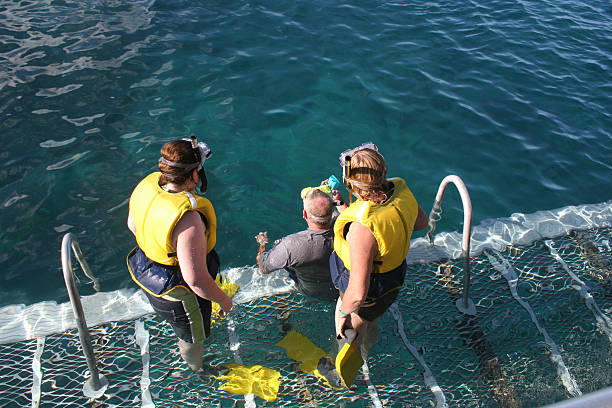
[330,143,428,360]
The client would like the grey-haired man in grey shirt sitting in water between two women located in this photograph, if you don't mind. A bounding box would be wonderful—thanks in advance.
[255,188,338,300]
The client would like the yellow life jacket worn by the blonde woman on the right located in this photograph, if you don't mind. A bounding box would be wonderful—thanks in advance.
[334,177,419,273]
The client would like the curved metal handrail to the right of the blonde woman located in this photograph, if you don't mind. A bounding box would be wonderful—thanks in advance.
[427,174,476,315]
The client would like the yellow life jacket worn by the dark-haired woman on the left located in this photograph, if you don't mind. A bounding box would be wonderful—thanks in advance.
[130,172,217,265]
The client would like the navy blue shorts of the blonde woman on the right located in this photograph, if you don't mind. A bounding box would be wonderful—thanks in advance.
[329,252,407,322]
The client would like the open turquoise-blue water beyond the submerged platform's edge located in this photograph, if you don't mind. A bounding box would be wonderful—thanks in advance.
[0,0,612,305]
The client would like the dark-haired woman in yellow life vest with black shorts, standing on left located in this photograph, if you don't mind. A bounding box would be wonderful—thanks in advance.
[127,136,232,371]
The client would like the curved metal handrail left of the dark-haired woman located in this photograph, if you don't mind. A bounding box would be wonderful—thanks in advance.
[62,233,108,399]
